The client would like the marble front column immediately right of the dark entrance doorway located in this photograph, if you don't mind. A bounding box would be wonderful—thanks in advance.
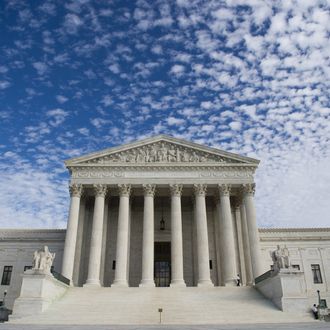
[170,184,186,287]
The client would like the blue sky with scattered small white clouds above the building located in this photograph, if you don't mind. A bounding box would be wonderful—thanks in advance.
[0,0,330,227]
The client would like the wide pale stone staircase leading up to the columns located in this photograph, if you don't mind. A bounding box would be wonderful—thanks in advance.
[11,287,312,325]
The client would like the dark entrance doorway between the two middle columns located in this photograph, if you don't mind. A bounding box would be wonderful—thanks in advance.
[154,242,171,287]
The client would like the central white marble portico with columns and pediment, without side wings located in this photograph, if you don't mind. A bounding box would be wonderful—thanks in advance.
[62,136,264,287]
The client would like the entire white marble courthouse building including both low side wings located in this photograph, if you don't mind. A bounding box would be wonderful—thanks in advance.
[0,135,330,324]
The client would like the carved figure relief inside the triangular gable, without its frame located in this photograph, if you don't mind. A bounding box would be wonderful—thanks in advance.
[82,142,237,164]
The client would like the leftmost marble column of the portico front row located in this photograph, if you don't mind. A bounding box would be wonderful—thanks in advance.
[62,184,83,284]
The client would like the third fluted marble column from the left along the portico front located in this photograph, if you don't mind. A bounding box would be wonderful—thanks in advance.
[112,184,131,287]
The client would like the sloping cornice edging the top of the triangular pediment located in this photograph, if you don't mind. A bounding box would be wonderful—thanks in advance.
[64,134,260,167]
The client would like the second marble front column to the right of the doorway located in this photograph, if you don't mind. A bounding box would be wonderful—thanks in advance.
[194,184,212,286]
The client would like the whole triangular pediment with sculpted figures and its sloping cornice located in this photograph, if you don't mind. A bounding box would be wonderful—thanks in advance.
[66,135,259,166]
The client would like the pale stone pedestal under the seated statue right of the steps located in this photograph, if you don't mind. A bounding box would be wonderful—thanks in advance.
[255,268,310,313]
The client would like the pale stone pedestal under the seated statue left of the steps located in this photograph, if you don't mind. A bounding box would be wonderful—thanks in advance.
[10,270,69,319]
